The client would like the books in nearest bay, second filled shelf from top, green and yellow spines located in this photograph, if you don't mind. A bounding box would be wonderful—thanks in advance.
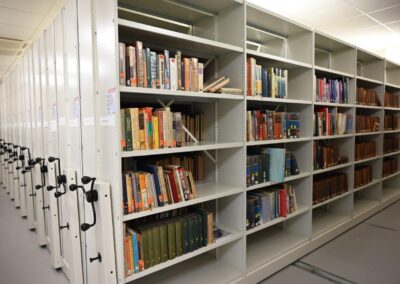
[121,107,204,151]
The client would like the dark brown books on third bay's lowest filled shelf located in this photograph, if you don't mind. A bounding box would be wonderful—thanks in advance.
[313,173,349,204]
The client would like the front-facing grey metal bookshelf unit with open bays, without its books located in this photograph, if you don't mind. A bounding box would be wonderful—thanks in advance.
[96,0,400,283]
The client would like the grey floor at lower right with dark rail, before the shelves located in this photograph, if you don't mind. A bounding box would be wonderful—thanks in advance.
[260,202,400,284]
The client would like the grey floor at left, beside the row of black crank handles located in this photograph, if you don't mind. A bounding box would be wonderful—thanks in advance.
[0,189,68,284]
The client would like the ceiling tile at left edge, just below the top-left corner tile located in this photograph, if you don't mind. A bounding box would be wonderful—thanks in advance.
[0,7,43,28]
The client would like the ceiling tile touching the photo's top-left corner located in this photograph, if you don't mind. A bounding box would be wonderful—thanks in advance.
[0,0,56,15]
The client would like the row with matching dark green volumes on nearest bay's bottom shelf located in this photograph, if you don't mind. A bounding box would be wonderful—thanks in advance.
[124,208,215,276]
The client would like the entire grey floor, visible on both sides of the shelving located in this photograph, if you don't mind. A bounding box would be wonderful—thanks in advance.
[0,186,400,284]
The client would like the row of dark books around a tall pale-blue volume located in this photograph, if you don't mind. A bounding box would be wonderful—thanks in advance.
[246,148,300,186]
